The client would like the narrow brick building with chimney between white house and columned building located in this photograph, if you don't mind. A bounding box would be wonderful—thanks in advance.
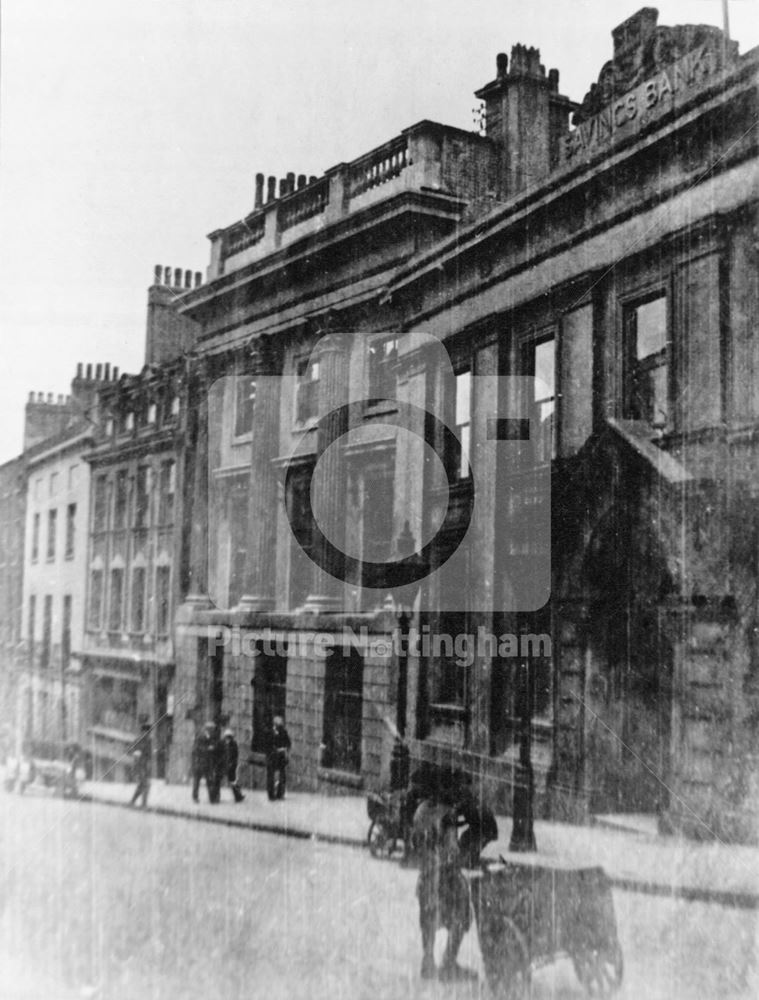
[81,267,200,778]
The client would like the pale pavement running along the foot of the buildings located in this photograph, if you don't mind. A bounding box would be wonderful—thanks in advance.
[81,780,759,909]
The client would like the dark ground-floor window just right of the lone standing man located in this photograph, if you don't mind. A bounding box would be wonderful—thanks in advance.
[322,649,364,773]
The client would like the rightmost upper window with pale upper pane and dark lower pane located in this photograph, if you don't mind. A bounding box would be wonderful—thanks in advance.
[624,295,669,427]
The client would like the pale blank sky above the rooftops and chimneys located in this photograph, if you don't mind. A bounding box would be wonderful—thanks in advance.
[0,0,759,462]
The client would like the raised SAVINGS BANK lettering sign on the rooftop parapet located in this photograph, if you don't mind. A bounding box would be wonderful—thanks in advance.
[563,45,723,162]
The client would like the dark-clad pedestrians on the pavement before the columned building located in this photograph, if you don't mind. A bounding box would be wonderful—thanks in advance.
[130,716,290,808]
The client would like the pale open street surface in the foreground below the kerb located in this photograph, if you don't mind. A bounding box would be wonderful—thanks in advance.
[0,792,759,1000]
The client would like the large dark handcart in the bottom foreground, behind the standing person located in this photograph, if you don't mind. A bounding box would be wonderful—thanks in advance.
[468,858,623,1000]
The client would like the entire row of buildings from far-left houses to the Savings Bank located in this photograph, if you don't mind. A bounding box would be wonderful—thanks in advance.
[0,8,759,841]
